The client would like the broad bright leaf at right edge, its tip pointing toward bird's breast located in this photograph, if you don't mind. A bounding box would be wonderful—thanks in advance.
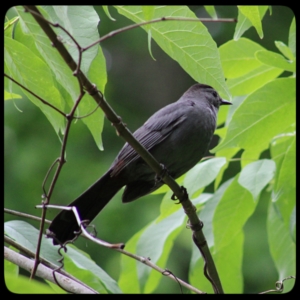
[213,78,296,152]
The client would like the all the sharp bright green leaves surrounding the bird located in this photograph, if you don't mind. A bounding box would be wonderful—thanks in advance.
[4,6,296,293]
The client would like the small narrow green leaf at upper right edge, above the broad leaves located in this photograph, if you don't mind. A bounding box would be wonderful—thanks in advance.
[255,50,296,72]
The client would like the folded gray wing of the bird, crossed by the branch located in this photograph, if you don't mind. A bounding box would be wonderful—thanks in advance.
[111,102,192,176]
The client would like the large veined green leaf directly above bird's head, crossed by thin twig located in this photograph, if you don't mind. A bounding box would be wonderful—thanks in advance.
[116,6,230,98]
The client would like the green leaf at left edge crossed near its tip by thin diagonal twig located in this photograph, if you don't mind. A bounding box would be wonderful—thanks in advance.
[4,37,65,133]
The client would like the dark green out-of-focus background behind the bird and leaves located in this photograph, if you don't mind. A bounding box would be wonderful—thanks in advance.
[4,6,294,293]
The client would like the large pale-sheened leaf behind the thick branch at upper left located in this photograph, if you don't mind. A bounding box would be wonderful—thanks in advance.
[17,6,107,150]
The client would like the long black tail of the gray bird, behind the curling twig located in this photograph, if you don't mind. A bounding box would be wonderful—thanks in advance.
[49,171,125,245]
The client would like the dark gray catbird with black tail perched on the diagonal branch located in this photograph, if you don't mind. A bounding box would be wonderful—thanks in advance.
[49,84,231,245]
